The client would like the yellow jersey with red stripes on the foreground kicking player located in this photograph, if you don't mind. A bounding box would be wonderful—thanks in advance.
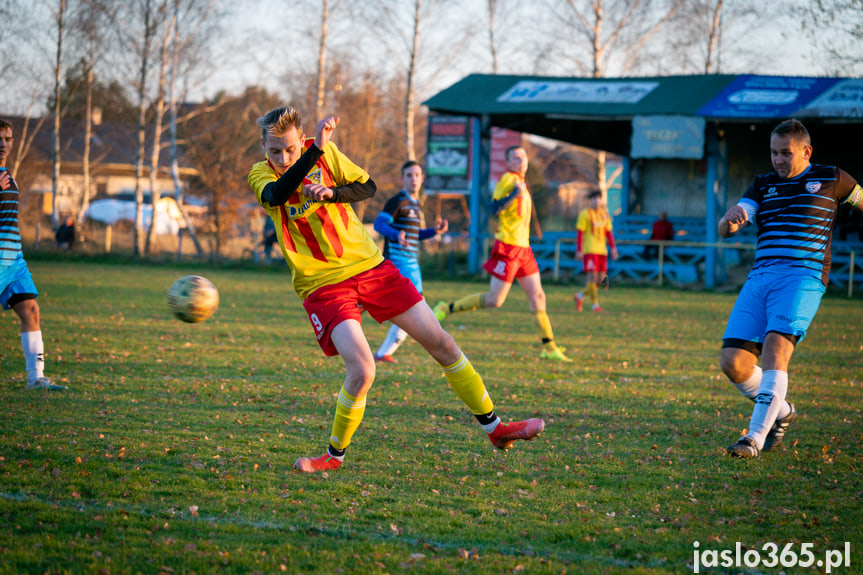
[249,138,384,299]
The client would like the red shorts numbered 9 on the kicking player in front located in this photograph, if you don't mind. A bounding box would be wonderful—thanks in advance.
[303,260,423,355]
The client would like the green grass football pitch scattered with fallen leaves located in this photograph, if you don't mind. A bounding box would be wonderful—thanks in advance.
[0,262,863,574]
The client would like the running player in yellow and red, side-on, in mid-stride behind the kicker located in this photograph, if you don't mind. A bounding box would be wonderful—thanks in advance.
[434,146,571,361]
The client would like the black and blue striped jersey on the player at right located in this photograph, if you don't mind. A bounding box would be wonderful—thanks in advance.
[740,164,857,285]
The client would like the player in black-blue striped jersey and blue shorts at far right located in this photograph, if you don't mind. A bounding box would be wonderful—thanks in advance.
[719,119,863,458]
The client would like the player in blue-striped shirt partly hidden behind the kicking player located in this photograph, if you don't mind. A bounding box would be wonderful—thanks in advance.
[375,160,449,363]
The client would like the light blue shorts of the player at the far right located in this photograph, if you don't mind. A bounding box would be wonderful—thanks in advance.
[722,273,826,347]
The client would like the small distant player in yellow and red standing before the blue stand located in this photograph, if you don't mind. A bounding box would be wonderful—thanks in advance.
[572,190,617,311]
